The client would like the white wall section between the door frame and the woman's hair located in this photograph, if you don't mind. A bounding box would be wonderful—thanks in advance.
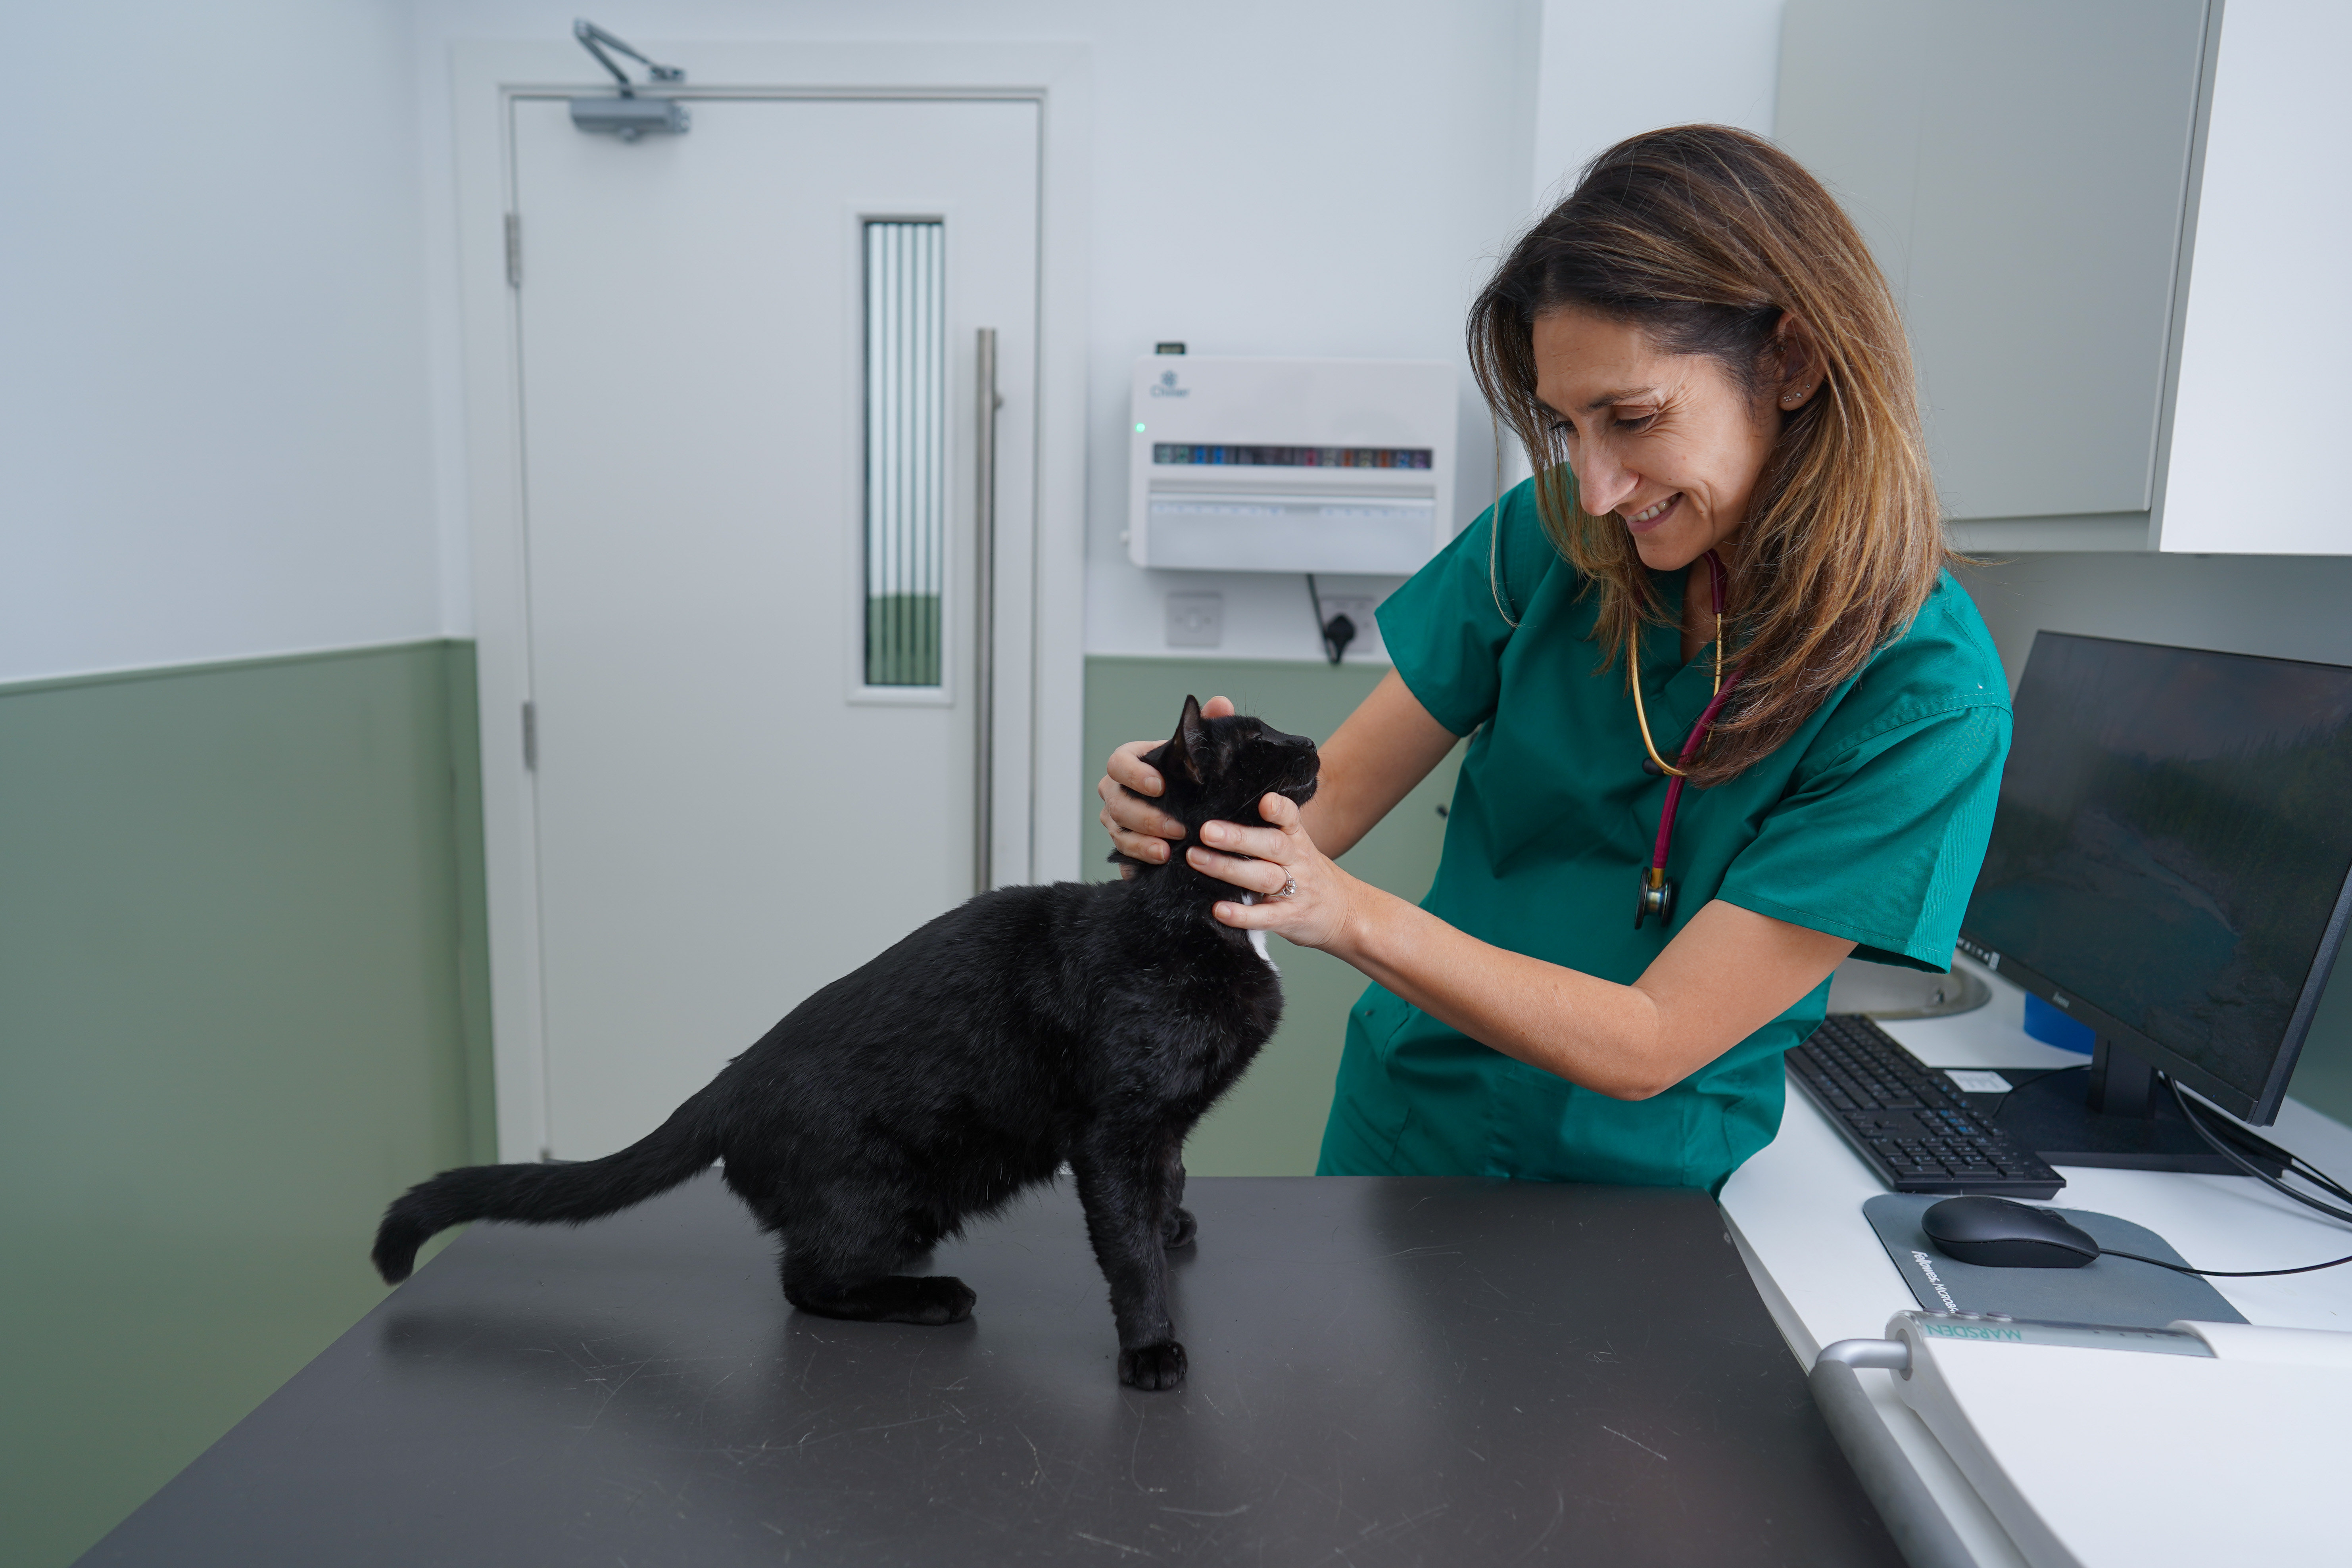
[1068,0,1536,658]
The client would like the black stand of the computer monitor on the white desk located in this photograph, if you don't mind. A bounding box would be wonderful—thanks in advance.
[1971,1037,2286,1175]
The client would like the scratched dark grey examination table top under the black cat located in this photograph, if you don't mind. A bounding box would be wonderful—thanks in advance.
[83,1175,1901,1568]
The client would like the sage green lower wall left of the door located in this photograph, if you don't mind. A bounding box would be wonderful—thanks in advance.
[0,642,492,1568]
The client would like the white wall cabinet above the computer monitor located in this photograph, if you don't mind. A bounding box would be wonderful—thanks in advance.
[1776,0,2352,555]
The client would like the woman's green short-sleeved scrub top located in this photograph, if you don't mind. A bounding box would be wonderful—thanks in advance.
[1319,482,2008,1192]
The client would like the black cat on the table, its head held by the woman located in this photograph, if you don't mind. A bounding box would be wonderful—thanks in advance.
[374,698,1317,1390]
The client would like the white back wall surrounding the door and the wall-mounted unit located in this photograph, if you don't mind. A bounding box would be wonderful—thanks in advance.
[402,0,1540,658]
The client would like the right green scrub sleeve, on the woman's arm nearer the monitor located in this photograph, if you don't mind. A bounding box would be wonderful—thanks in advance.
[1717,703,2008,973]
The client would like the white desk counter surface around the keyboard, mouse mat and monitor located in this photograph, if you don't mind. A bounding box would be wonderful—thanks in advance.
[1722,971,2352,1568]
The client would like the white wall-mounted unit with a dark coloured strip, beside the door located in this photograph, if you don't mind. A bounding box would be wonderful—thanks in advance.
[1127,355,1456,576]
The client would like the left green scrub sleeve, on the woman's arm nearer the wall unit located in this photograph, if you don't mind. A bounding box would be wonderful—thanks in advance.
[1376,484,1569,736]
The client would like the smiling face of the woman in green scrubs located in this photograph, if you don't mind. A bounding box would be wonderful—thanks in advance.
[1534,305,1778,571]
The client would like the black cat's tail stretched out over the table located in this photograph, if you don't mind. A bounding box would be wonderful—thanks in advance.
[372,1088,720,1286]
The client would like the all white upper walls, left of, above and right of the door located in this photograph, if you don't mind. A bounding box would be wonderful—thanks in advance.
[0,0,1778,679]
